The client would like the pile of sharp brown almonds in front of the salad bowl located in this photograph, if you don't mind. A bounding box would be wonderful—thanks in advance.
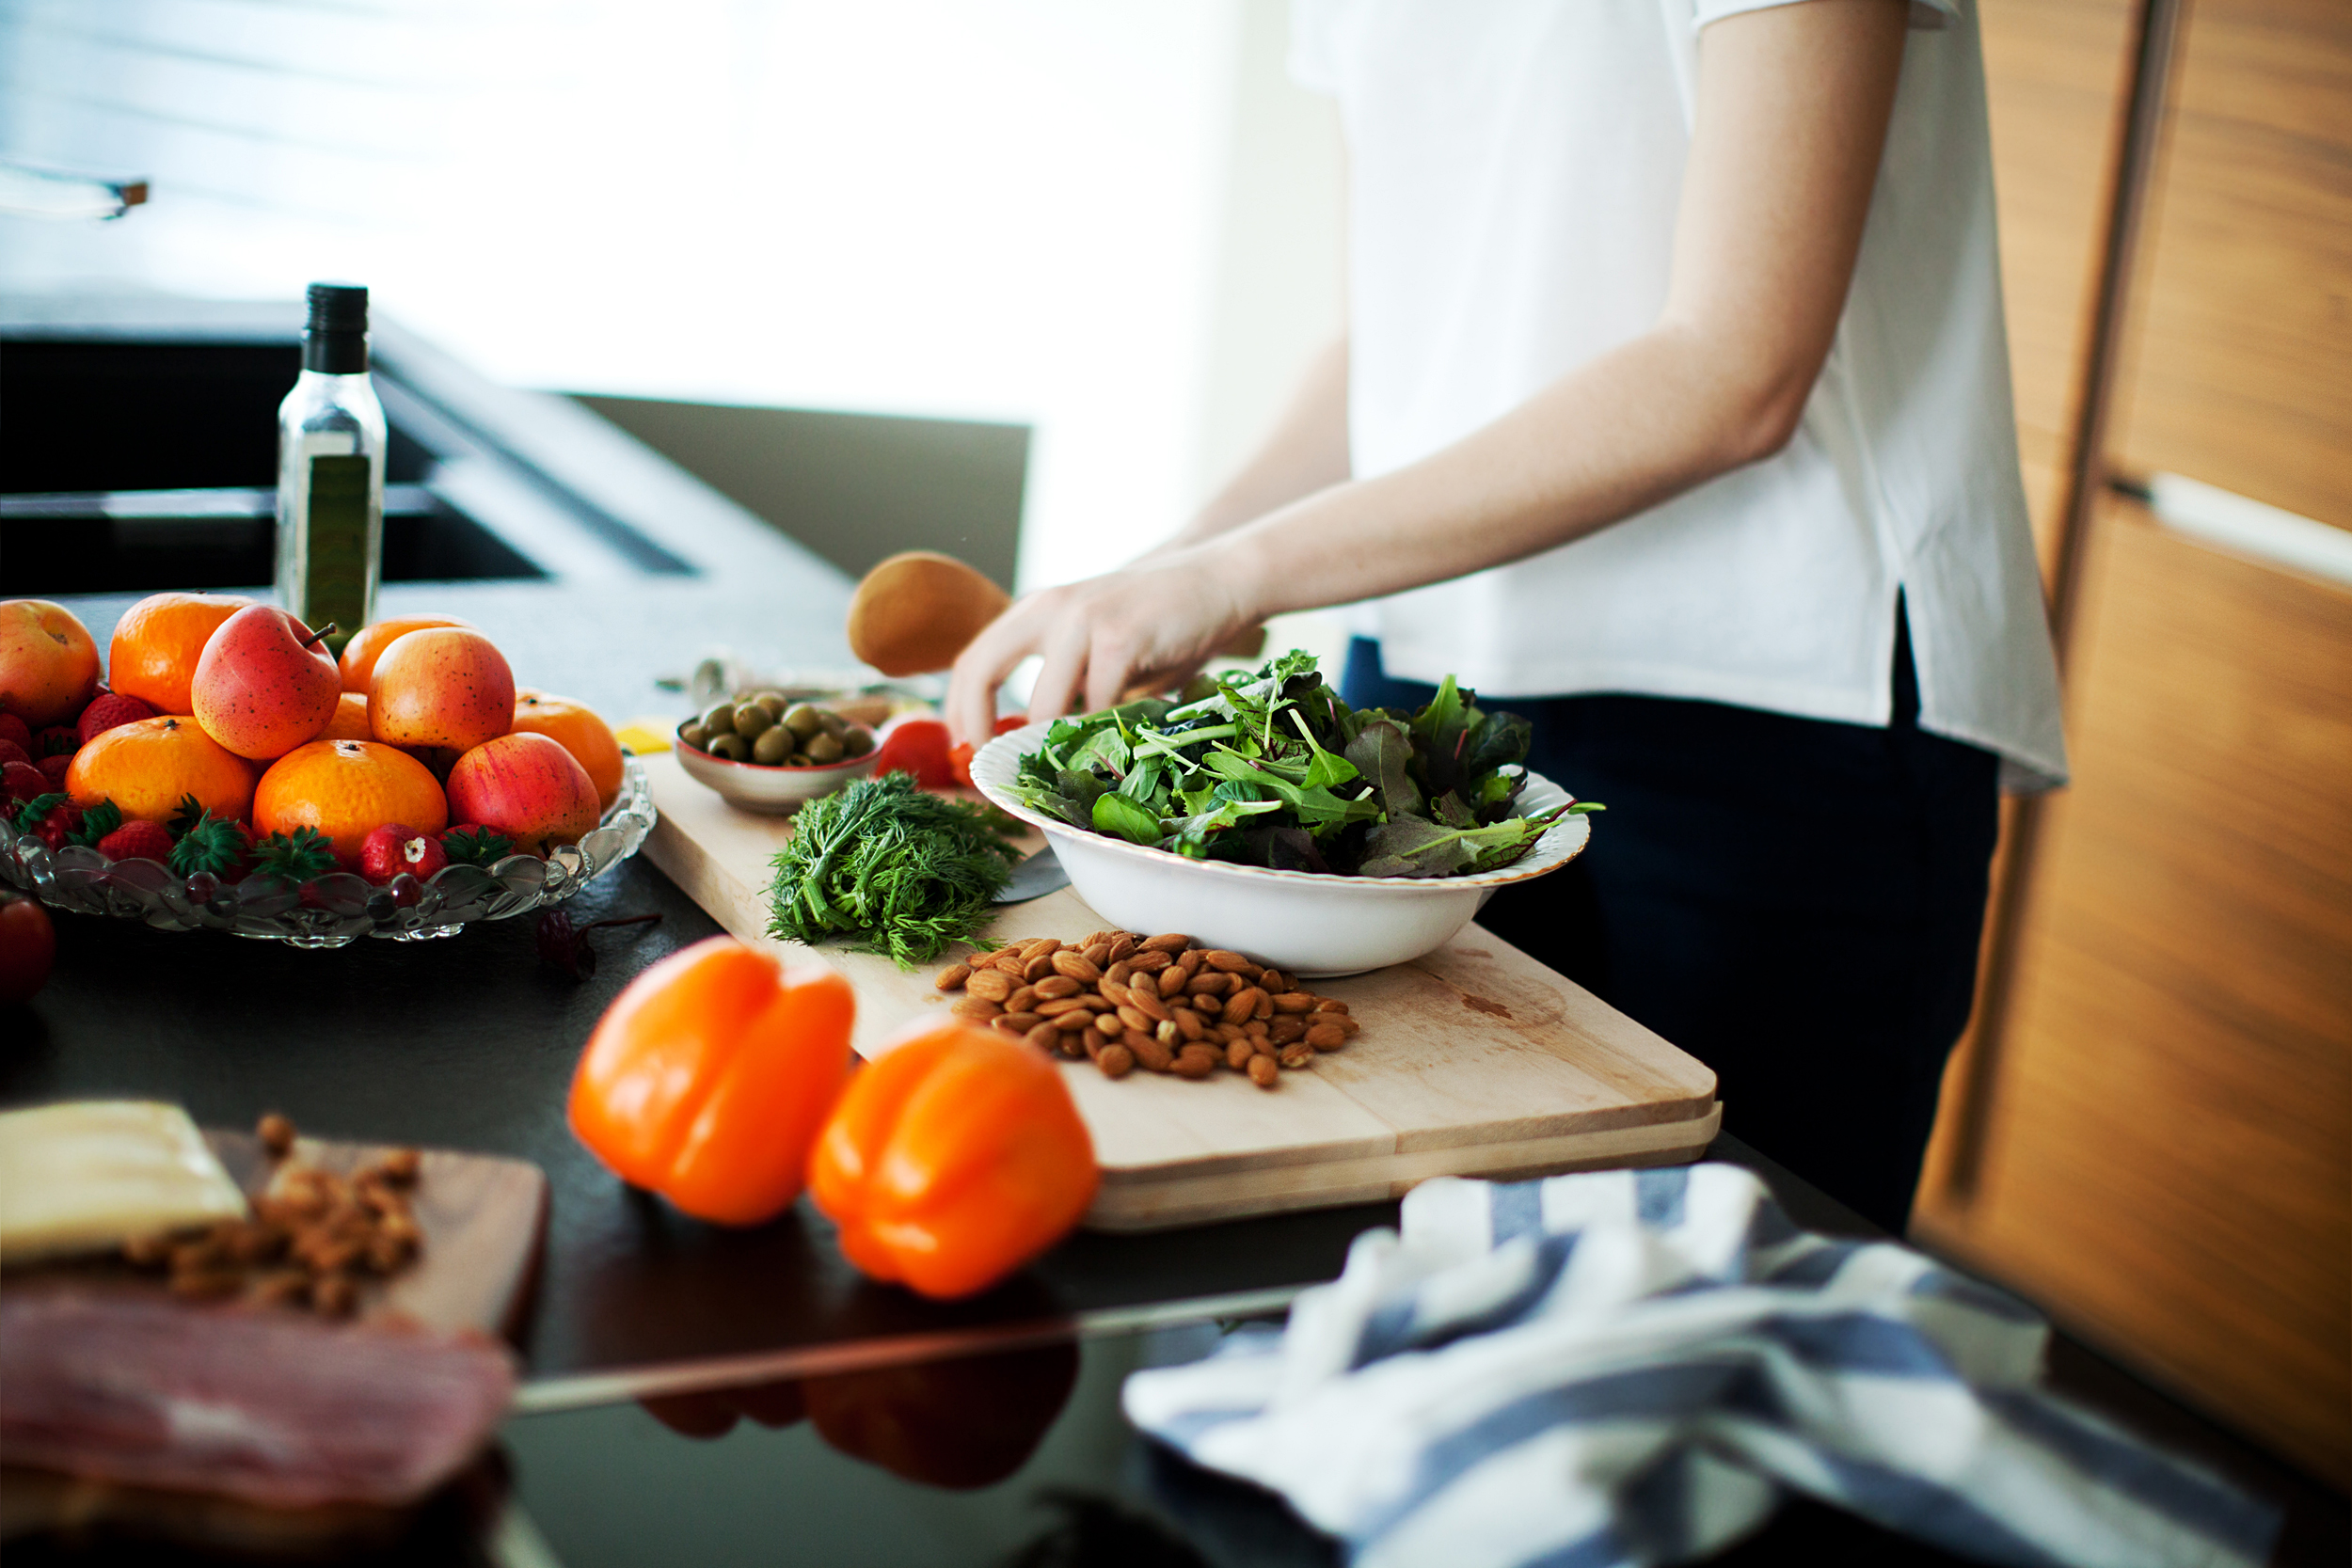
[936,931,1358,1088]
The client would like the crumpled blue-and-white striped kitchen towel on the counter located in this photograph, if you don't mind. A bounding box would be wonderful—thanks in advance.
[1124,1164,2277,1568]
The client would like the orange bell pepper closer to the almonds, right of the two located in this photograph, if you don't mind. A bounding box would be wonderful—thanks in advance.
[809,1018,1096,1298]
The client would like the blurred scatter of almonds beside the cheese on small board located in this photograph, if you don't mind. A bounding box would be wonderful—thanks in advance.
[122,1112,423,1317]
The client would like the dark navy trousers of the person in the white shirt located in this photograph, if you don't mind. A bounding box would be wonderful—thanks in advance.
[1341,618,1999,1234]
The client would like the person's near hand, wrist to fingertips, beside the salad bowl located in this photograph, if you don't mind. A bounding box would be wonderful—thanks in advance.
[946,538,1263,745]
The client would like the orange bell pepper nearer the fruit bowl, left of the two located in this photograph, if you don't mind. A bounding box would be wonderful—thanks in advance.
[572,936,856,1225]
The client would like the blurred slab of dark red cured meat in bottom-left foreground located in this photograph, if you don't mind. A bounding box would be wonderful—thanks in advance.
[0,1291,516,1507]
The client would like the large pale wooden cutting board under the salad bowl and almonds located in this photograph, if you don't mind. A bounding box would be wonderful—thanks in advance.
[644,754,1722,1229]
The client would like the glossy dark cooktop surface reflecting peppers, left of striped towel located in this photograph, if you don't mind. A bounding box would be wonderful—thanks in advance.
[501,1323,1341,1568]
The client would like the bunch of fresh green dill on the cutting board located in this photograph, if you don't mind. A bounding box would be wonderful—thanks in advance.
[767,773,1019,969]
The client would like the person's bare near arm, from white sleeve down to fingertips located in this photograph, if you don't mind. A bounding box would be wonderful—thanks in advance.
[948,0,1908,738]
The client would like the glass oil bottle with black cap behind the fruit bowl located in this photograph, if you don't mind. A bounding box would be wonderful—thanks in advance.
[278,282,386,649]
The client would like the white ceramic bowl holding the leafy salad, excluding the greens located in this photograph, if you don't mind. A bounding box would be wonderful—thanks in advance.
[972,724,1593,975]
